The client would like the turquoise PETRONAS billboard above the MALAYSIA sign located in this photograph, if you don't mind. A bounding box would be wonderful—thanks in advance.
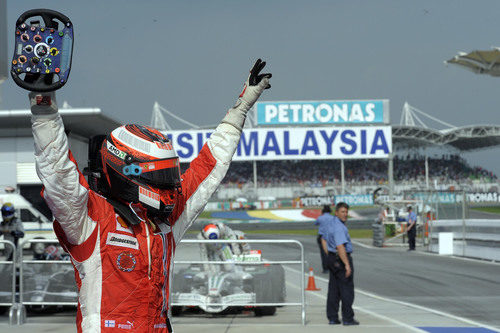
[256,99,390,126]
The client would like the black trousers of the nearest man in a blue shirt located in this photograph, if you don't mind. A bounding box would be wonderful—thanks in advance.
[326,252,354,322]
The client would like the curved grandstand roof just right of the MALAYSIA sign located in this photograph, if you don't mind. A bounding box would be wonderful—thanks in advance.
[392,125,500,151]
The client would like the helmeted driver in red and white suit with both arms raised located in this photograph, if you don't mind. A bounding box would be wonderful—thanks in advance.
[29,59,271,332]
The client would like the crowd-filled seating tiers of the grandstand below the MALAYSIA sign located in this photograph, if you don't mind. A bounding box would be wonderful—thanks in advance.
[210,154,497,187]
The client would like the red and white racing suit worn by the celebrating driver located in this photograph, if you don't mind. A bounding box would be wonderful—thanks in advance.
[30,70,268,332]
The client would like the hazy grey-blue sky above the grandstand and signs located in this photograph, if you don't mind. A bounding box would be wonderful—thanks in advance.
[0,0,500,174]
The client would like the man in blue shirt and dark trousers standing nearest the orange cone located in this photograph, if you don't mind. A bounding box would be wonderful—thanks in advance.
[322,202,359,325]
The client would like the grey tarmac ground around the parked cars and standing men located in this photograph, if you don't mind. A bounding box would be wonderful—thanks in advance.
[0,209,500,333]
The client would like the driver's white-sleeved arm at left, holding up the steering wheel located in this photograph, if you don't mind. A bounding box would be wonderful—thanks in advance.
[29,92,95,245]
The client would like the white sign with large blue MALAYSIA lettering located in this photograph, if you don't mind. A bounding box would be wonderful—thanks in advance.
[165,126,392,163]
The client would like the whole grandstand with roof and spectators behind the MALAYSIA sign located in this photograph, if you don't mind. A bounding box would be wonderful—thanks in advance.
[152,103,500,200]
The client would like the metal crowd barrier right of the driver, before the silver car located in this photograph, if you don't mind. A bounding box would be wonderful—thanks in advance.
[172,239,306,325]
